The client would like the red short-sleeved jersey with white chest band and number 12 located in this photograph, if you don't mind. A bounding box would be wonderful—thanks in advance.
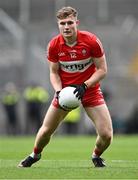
[47,30,104,90]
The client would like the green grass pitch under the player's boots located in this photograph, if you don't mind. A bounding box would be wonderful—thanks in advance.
[0,135,138,179]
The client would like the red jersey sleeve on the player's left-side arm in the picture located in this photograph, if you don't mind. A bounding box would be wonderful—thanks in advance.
[46,41,58,63]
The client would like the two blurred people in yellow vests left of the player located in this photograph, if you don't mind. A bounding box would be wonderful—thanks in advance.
[1,82,49,135]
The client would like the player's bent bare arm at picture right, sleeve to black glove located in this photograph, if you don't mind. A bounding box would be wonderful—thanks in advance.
[85,55,107,88]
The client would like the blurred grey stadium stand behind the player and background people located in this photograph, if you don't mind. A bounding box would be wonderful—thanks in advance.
[0,0,138,135]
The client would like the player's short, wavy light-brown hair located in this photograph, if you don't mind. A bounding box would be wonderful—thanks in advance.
[56,6,78,19]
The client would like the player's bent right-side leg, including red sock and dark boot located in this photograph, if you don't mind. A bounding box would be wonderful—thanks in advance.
[85,104,113,167]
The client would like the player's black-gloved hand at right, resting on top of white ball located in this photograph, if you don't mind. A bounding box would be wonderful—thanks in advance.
[71,83,87,99]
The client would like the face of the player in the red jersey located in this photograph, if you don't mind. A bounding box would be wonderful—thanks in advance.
[58,16,79,40]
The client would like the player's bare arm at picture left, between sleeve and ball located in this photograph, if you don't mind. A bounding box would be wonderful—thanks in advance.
[49,61,62,92]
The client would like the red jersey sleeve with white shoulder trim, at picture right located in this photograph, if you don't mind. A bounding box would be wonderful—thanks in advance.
[91,35,104,58]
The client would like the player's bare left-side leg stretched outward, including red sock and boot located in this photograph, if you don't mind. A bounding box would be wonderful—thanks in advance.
[18,104,68,167]
